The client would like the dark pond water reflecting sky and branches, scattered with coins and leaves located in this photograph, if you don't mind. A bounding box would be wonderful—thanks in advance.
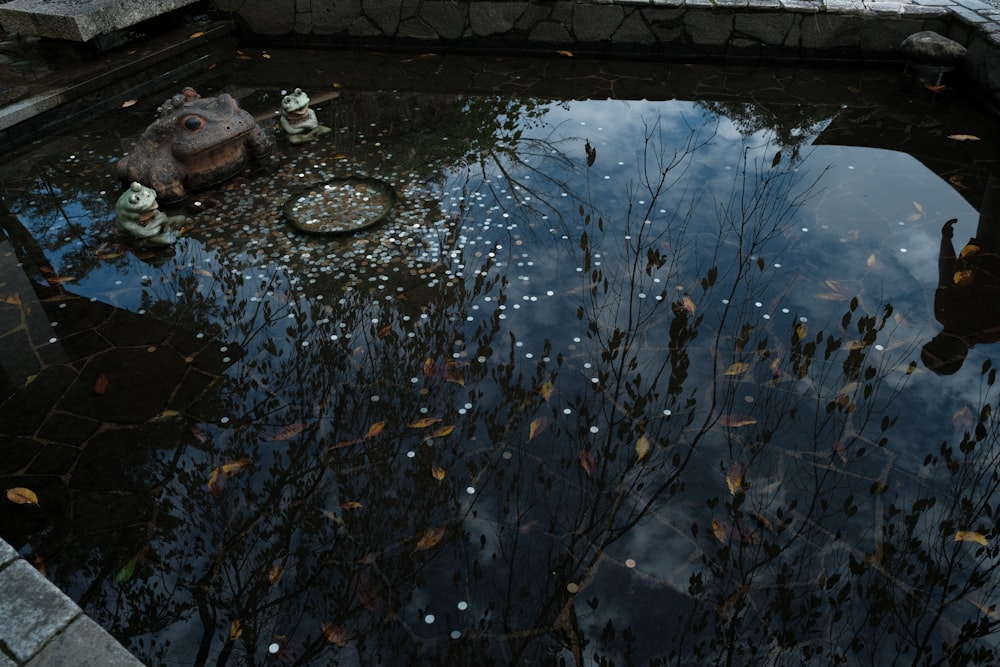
[0,50,1000,665]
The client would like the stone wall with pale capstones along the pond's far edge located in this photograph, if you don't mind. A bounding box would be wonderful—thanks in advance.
[212,0,1000,102]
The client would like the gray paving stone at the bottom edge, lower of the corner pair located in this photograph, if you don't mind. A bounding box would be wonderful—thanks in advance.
[25,615,142,667]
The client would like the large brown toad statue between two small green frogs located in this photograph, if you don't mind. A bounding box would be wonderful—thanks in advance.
[116,87,272,204]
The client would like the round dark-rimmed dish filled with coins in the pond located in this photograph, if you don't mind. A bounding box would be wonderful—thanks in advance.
[285,176,396,234]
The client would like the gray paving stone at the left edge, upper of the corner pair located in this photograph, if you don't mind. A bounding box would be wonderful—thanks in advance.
[0,560,81,661]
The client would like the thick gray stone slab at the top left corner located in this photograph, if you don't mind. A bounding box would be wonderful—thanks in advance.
[0,0,203,42]
